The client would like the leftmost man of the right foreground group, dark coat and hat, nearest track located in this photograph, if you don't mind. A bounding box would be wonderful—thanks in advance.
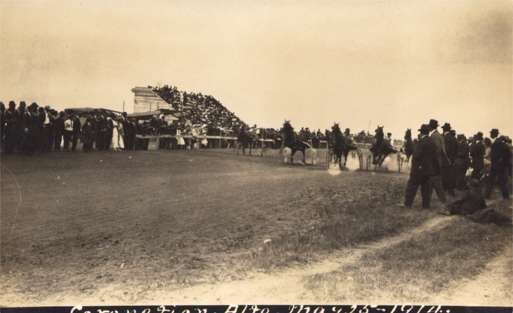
[404,124,440,209]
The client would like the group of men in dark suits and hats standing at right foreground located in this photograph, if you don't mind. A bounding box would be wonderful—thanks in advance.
[404,119,512,209]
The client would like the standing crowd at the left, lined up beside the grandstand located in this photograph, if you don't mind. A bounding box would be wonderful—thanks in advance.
[0,101,136,155]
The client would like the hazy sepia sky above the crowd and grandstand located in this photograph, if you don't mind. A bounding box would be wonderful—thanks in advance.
[0,0,513,137]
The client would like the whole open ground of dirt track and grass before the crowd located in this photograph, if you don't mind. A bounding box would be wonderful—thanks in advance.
[0,151,513,305]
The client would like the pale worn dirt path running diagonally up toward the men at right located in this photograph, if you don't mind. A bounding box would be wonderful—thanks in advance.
[136,217,453,304]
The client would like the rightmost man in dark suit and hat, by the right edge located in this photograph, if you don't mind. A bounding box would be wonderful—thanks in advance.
[485,128,511,199]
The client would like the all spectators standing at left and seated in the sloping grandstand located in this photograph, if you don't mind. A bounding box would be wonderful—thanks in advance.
[0,96,382,154]
